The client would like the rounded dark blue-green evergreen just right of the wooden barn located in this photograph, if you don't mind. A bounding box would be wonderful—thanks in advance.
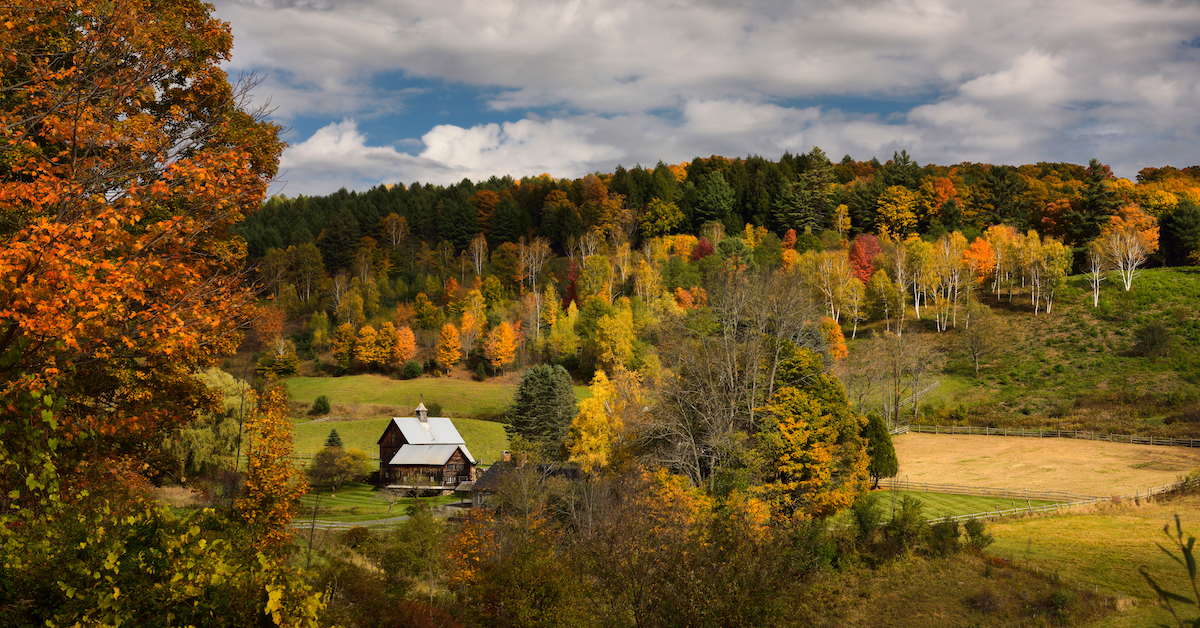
[504,364,578,456]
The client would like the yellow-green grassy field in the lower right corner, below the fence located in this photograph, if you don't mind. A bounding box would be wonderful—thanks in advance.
[989,495,1200,628]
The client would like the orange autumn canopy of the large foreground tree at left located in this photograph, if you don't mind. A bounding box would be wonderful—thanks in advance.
[0,0,283,456]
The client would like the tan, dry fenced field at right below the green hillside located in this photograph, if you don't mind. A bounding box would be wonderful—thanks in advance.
[894,433,1200,496]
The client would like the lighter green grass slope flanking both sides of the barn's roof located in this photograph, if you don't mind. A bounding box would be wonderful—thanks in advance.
[292,417,509,461]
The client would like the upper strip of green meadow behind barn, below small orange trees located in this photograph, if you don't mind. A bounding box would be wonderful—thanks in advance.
[287,375,588,418]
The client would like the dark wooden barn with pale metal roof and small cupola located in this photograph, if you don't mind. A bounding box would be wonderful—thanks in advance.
[379,403,475,488]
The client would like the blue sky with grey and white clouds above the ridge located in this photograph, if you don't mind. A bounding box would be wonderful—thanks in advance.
[212,0,1200,196]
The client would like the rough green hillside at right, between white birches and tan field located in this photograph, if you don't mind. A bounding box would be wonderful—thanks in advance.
[850,268,1200,437]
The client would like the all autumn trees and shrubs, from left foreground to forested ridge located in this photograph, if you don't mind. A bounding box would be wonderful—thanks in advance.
[0,0,1200,626]
